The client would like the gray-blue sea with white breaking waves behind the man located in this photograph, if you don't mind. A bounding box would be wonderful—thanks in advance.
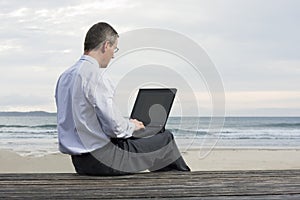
[0,113,300,156]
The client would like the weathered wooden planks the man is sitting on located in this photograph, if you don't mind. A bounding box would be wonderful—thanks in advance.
[0,170,300,200]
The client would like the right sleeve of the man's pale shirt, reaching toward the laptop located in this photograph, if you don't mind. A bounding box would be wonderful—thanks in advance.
[92,72,135,138]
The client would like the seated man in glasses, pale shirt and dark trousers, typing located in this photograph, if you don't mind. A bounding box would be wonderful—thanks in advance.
[55,22,190,175]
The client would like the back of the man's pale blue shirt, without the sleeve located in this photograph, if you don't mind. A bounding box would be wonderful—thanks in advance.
[55,56,109,155]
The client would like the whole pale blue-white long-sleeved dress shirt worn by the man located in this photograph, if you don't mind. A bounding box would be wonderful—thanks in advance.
[55,55,135,155]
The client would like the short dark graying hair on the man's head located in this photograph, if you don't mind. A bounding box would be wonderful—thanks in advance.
[84,22,119,52]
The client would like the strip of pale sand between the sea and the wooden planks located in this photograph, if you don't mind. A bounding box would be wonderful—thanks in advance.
[0,148,300,173]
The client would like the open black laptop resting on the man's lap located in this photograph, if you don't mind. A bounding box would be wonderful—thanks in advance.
[130,88,177,137]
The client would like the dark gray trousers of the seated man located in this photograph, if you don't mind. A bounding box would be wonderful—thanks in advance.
[72,130,190,175]
